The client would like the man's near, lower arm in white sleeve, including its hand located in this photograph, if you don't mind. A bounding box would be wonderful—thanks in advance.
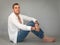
[8,18,35,31]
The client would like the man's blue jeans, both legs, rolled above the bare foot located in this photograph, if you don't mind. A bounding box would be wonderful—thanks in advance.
[17,21,44,42]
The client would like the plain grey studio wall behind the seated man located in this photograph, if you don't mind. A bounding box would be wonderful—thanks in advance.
[0,0,60,36]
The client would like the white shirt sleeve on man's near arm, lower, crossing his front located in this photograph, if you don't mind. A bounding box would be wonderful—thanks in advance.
[11,18,31,31]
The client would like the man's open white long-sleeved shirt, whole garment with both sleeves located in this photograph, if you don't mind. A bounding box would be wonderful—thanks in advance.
[8,12,36,43]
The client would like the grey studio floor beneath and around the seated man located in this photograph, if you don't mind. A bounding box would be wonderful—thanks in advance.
[0,34,60,45]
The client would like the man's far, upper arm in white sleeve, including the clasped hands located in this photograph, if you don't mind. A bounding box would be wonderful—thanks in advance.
[22,15,40,31]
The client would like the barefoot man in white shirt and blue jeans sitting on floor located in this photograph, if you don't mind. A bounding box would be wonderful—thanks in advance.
[8,3,55,43]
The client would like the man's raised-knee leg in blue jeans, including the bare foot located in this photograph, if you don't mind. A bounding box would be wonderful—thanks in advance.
[28,21,55,42]
